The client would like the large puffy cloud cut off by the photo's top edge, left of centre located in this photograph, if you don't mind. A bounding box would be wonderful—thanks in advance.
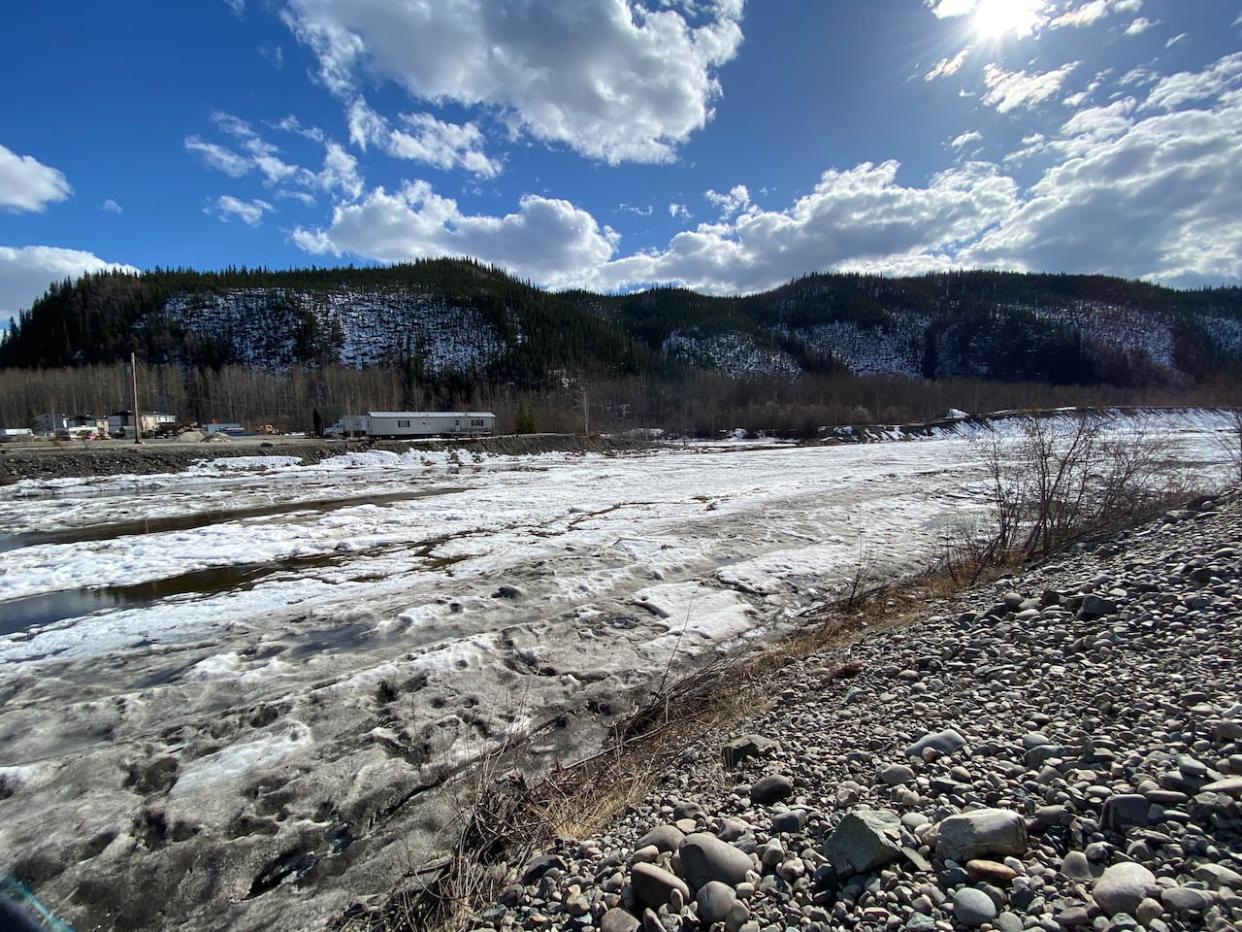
[283,0,744,164]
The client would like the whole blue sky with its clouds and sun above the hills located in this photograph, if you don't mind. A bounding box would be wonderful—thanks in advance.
[0,0,1242,321]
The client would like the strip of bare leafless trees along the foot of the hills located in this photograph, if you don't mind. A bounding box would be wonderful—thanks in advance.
[0,364,1242,437]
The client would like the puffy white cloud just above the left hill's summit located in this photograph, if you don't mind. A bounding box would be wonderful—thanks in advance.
[293,181,617,287]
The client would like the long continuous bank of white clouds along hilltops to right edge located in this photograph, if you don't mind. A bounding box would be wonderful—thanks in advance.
[285,56,1242,293]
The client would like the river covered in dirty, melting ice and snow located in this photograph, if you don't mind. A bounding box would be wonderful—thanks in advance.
[0,416,1221,928]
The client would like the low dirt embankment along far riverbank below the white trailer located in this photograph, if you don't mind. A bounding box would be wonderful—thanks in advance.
[0,434,652,485]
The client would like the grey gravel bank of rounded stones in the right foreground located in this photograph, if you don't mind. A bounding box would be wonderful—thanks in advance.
[472,497,1242,932]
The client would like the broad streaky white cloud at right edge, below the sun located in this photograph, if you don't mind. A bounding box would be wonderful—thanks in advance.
[959,80,1242,285]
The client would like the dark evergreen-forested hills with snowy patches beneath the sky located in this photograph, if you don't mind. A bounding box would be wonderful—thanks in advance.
[0,260,1242,385]
